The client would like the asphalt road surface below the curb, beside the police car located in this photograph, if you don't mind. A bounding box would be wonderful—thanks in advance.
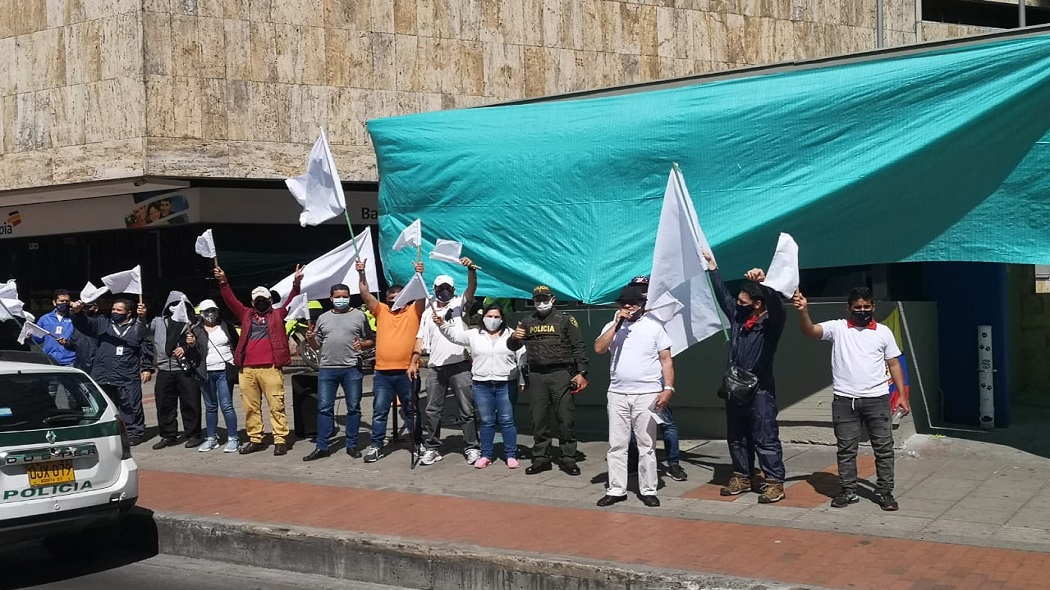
[0,544,401,590]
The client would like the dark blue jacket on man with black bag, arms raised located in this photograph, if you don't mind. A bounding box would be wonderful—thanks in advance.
[710,270,786,392]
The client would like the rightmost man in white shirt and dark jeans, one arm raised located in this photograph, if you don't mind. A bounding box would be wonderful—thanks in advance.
[795,287,911,510]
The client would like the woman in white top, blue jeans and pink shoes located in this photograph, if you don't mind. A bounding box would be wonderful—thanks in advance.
[434,304,521,469]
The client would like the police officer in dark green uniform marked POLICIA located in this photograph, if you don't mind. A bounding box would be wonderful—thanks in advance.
[507,285,587,476]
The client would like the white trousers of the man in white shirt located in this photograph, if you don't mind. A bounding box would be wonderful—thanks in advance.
[606,392,659,496]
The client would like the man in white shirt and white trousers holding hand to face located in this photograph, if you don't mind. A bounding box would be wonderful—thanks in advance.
[594,285,674,508]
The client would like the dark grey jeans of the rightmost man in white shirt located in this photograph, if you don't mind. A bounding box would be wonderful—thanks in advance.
[832,395,894,494]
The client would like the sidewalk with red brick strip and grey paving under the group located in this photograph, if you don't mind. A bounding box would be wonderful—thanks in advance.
[134,373,1050,590]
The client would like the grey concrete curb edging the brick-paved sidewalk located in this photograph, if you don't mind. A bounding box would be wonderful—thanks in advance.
[124,509,824,590]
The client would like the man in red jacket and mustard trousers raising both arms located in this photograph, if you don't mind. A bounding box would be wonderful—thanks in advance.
[215,265,302,457]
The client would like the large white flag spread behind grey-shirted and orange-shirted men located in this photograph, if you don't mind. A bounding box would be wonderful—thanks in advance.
[273,228,379,300]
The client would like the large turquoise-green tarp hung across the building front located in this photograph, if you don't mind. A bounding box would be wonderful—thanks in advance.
[369,35,1050,302]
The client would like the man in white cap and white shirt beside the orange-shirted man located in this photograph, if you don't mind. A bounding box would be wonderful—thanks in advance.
[408,258,481,465]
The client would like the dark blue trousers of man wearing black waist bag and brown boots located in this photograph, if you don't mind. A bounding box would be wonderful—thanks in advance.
[726,388,785,483]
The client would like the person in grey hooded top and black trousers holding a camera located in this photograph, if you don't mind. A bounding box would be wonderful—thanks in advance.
[149,291,202,450]
